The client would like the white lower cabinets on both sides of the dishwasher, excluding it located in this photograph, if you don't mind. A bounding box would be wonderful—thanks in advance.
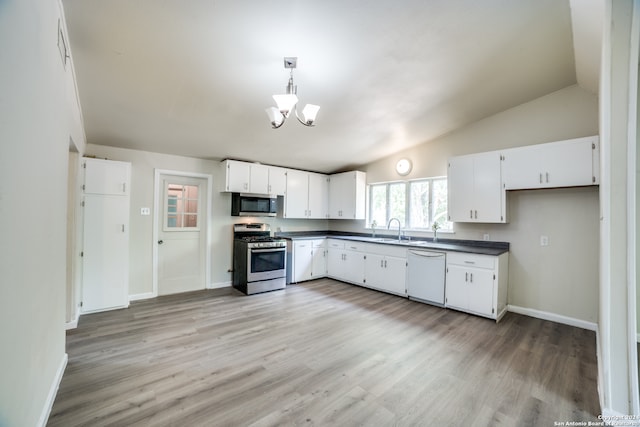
[316,239,509,320]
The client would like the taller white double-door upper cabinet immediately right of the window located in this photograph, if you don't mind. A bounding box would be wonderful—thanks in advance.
[448,151,507,223]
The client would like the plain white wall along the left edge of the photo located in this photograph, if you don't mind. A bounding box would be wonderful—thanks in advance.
[0,0,84,426]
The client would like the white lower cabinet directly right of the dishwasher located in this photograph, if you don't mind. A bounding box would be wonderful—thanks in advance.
[445,252,509,320]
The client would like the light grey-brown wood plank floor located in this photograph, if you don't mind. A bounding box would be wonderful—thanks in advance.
[48,279,600,426]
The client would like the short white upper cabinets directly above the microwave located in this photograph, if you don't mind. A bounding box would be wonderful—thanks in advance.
[222,160,286,196]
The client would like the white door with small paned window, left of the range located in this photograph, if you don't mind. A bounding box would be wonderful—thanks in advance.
[156,175,208,295]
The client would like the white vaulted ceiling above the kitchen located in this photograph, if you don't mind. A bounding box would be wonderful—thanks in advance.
[63,0,602,172]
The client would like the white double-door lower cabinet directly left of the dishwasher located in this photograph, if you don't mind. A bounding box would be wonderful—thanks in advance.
[364,245,407,296]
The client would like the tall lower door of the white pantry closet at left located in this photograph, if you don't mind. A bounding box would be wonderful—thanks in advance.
[82,194,129,313]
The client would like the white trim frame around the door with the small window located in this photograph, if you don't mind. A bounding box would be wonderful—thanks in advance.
[151,169,213,297]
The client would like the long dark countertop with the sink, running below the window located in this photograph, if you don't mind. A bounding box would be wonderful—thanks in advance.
[275,230,509,256]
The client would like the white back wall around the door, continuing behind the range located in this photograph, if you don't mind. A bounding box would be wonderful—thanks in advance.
[87,144,328,295]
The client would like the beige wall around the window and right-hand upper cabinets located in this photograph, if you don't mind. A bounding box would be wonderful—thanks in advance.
[330,86,599,327]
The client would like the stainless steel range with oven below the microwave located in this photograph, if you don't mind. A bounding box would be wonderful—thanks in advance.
[233,223,287,295]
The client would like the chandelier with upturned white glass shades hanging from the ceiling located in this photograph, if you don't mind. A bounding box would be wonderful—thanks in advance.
[265,57,320,129]
